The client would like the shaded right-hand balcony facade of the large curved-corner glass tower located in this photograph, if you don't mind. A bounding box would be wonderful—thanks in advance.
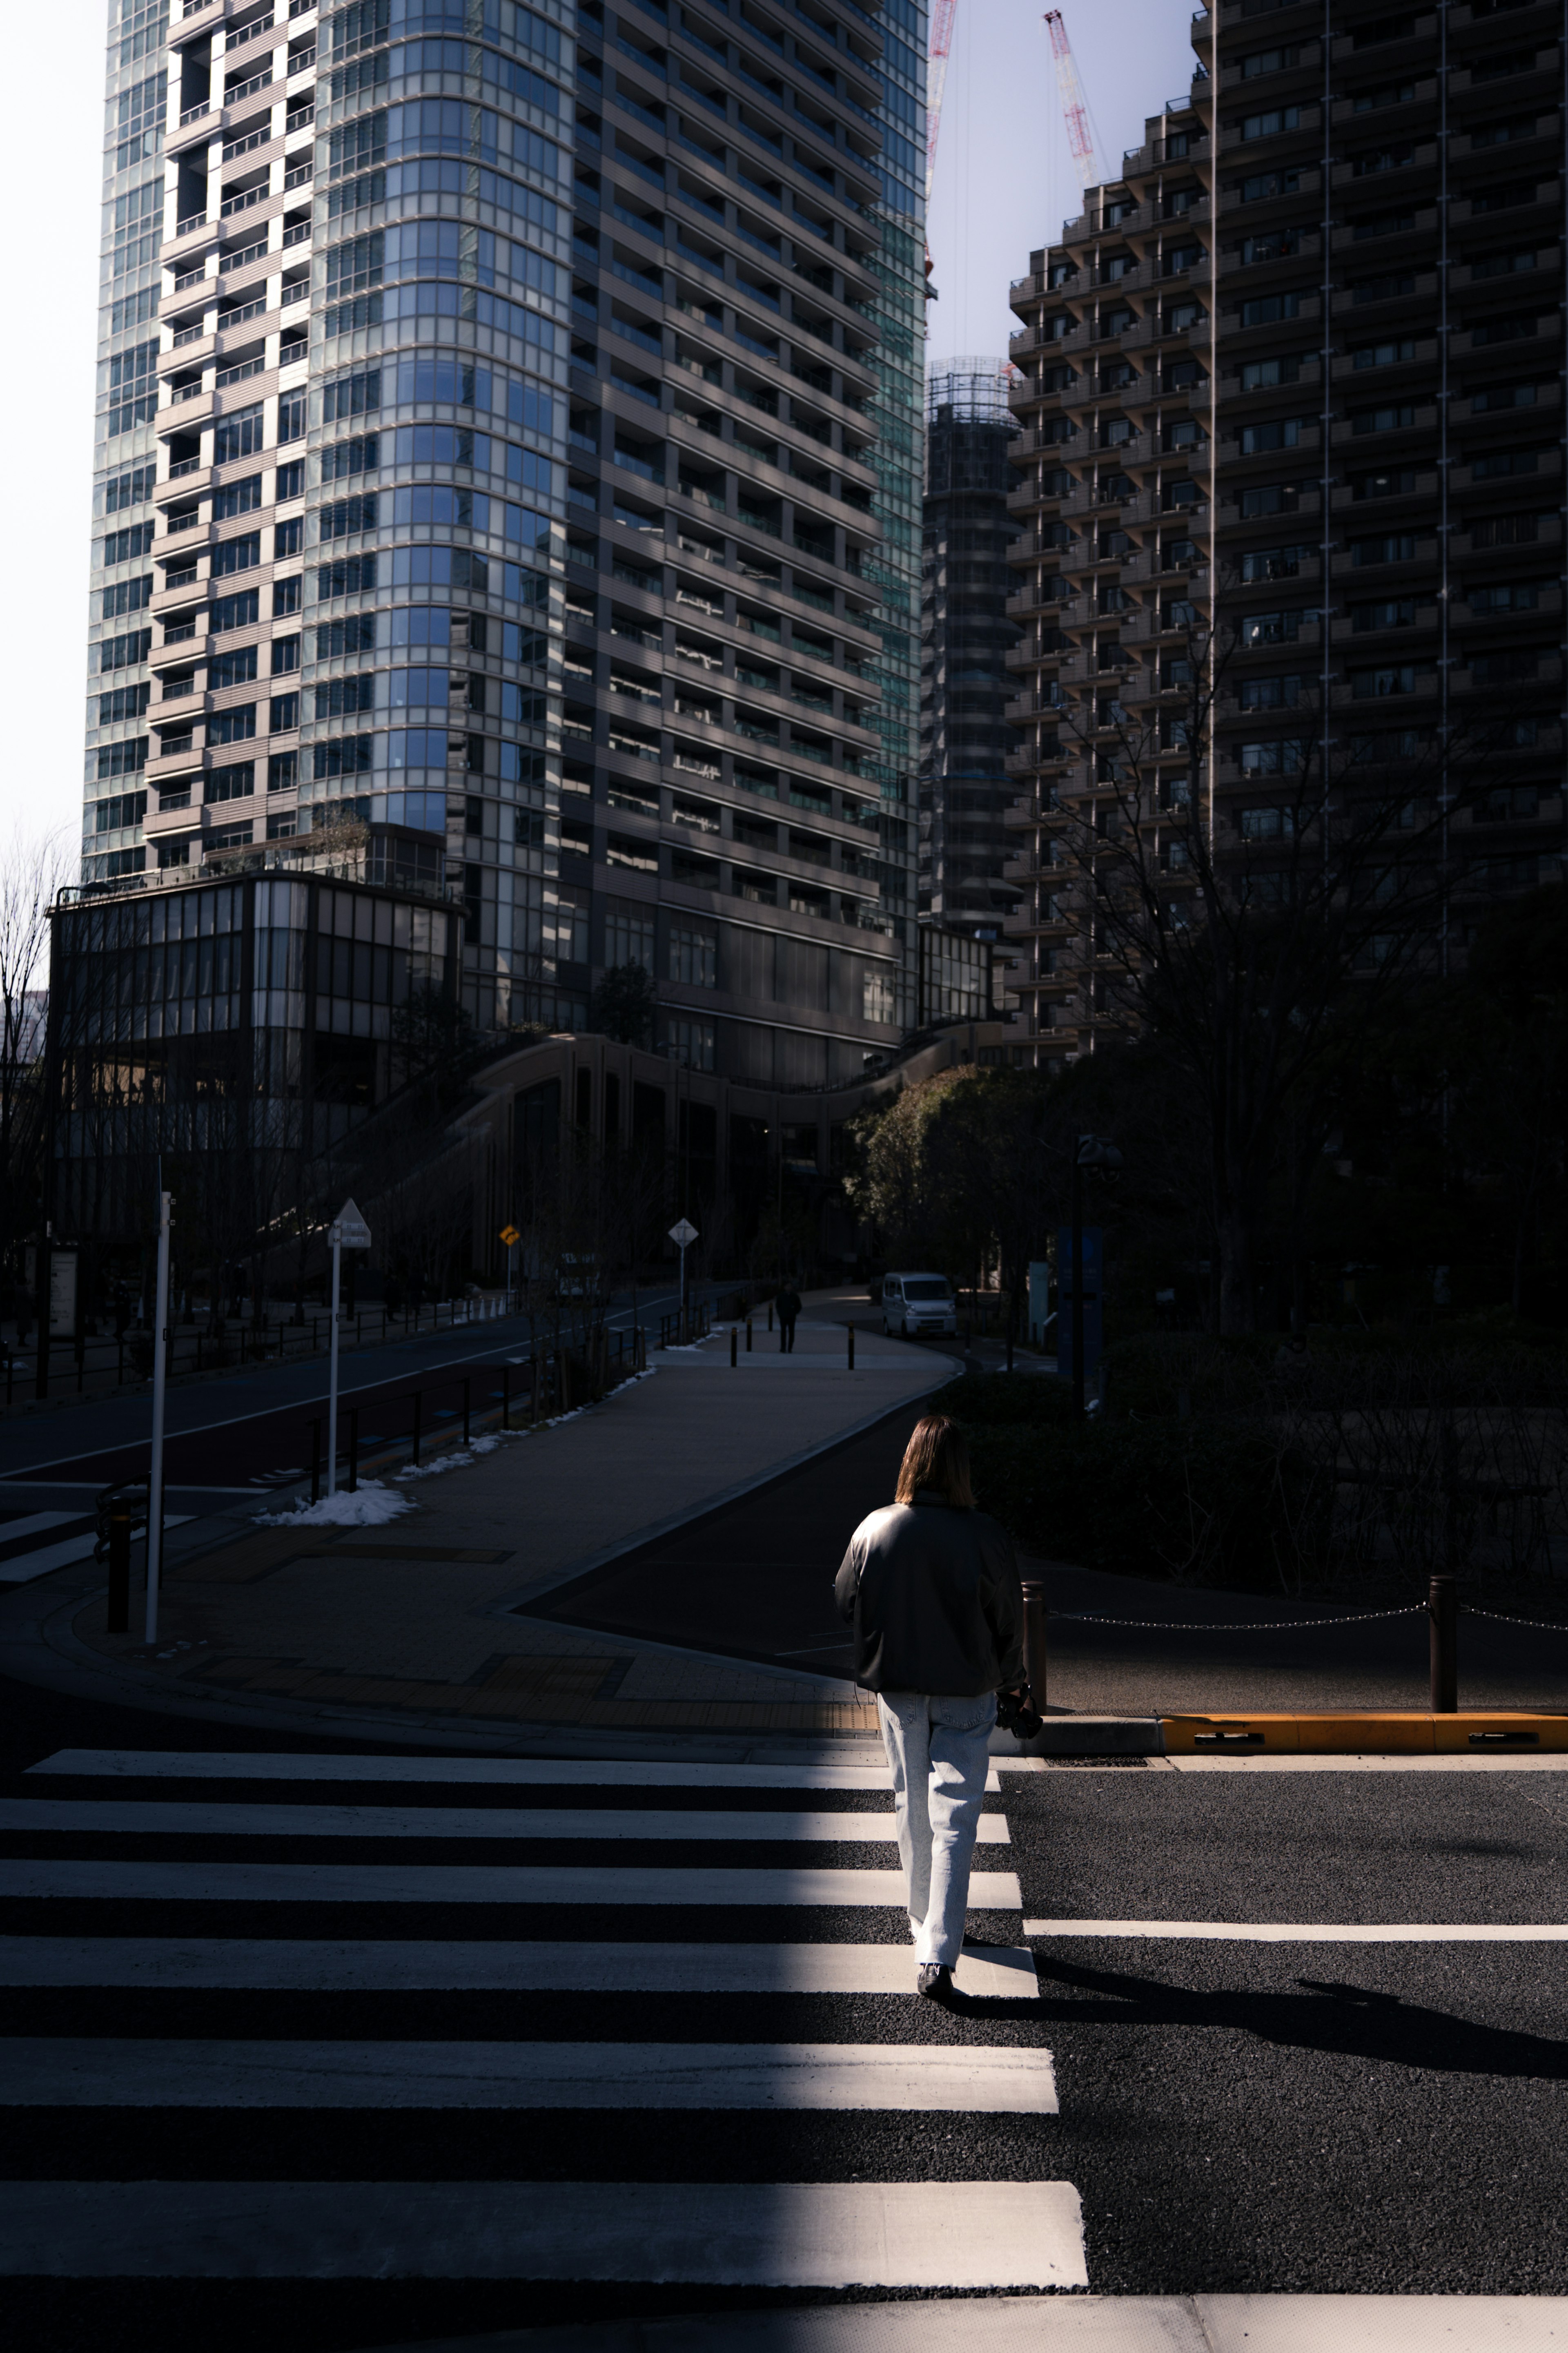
[562,0,924,1085]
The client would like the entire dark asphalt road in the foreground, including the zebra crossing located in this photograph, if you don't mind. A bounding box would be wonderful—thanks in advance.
[0,1656,1568,2353]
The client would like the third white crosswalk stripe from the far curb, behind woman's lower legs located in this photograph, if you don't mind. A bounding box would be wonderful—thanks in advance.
[0,1856,1022,1911]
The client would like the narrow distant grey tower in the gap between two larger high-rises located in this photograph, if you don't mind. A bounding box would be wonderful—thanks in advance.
[919,360,1018,1021]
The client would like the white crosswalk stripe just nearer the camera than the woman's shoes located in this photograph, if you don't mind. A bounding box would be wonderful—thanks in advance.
[0,2035,1056,2115]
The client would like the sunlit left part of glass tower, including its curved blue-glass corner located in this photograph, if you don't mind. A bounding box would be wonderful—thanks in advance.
[85,0,574,1026]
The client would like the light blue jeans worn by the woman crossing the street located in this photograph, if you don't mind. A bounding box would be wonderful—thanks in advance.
[877,1692,997,1969]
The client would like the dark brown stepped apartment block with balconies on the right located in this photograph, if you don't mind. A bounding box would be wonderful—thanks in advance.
[1009,0,1563,1061]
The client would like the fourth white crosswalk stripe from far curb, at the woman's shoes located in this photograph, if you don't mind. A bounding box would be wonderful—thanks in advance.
[0,1936,1039,2003]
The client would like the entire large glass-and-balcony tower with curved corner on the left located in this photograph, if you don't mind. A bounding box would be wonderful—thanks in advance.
[82,0,924,1085]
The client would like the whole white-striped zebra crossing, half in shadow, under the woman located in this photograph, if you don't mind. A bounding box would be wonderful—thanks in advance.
[0,1748,1089,2306]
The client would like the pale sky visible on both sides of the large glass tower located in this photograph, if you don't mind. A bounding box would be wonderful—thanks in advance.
[0,0,1192,854]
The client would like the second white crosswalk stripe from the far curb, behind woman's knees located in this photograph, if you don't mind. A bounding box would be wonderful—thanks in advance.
[0,1798,1009,1847]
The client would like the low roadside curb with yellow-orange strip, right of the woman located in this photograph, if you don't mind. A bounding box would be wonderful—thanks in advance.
[1020,1708,1568,1758]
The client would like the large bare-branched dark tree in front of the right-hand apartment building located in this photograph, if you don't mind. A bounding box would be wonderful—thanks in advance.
[1041,593,1495,1332]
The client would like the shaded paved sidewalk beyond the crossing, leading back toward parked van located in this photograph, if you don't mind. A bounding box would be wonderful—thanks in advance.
[27,1296,957,1734]
